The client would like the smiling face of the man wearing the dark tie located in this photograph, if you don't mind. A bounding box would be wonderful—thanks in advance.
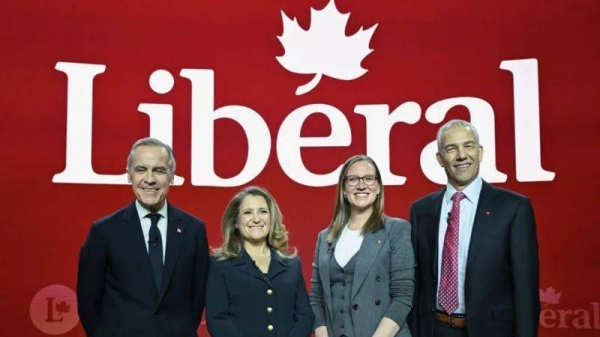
[127,146,173,212]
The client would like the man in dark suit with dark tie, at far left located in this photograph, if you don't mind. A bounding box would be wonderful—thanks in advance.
[77,138,209,337]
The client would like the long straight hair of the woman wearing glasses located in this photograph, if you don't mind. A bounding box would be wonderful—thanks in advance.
[327,155,386,242]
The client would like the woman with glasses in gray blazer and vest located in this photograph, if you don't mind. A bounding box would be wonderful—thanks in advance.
[310,155,415,337]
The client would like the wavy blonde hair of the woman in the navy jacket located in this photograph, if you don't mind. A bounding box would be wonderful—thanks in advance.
[213,186,297,260]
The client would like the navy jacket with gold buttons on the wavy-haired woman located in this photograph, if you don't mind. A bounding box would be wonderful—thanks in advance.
[206,248,314,337]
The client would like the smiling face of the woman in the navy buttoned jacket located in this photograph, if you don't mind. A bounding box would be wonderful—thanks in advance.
[237,195,271,244]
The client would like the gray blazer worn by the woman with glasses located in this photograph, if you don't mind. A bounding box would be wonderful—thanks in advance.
[310,218,415,337]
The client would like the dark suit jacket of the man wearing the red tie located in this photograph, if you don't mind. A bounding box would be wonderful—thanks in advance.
[409,181,540,337]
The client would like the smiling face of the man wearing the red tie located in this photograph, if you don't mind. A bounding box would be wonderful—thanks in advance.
[437,125,483,191]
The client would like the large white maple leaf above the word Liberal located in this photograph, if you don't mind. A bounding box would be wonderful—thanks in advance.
[276,0,377,95]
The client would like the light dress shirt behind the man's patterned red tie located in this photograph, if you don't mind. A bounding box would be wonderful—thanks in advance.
[436,177,483,314]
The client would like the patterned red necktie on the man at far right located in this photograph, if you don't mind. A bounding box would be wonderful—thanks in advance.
[438,192,466,314]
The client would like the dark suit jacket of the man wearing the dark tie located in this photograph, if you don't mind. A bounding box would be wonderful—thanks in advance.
[77,203,209,337]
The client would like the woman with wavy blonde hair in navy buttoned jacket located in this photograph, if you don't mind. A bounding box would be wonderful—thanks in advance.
[206,186,314,337]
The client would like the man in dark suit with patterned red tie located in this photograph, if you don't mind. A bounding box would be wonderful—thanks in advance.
[409,120,540,337]
